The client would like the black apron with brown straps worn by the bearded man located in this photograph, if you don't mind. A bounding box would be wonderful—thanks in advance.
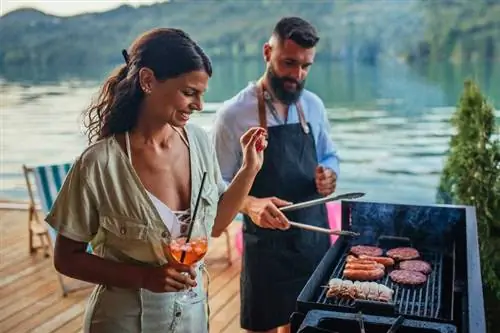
[241,84,330,331]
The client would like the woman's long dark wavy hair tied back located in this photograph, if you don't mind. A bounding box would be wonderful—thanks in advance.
[84,28,212,143]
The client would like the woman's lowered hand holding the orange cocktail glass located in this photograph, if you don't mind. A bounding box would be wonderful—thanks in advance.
[141,264,196,293]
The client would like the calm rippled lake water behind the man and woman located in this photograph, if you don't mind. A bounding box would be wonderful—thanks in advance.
[0,62,500,203]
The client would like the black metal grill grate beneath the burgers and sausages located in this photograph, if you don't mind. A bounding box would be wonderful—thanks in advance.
[318,247,444,319]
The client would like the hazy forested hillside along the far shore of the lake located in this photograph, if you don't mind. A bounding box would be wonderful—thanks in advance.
[0,0,500,70]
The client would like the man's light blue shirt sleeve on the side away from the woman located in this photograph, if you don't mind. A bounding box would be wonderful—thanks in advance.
[316,98,340,177]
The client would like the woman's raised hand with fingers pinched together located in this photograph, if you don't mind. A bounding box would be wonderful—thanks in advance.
[240,127,267,173]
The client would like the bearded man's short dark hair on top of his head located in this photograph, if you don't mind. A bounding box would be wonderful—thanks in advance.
[273,17,319,49]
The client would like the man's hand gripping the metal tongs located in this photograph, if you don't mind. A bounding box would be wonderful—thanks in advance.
[244,197,292,230]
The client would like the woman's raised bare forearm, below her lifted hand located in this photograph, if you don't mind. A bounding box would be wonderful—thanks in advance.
[212,168,256,237]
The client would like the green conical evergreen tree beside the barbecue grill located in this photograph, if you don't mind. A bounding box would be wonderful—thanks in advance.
[437,81,500,332]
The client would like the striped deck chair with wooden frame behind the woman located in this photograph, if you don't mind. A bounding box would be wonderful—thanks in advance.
[23,163,92,296]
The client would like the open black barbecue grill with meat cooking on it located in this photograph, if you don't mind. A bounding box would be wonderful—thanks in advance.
[291,201,486,333]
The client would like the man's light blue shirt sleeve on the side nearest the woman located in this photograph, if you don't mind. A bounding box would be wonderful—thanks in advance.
[213,106,241,185]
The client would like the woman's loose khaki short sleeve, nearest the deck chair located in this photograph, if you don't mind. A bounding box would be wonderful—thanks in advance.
[45,159,99,242]
